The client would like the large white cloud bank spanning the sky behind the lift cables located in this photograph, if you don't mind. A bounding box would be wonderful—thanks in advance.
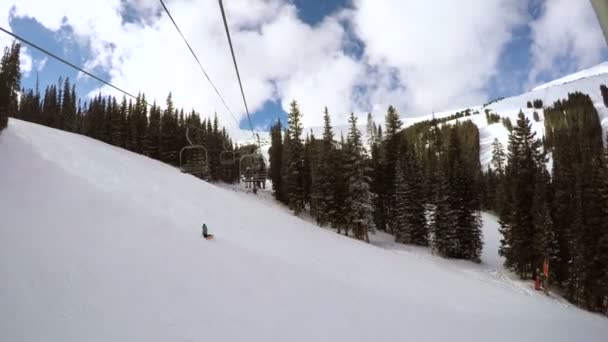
[0,0,525,129]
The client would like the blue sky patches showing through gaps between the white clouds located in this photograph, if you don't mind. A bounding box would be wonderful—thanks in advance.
[2,0,607,128]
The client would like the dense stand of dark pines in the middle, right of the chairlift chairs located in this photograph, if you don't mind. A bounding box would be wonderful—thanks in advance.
[269,101,482,262]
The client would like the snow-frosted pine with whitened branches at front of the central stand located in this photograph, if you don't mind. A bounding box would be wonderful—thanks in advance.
[345,113,375,242]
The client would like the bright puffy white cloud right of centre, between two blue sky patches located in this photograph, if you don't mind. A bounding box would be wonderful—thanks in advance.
[353,0,525,115]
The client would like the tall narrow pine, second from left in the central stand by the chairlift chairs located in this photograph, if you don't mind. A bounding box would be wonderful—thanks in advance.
[285,100,305,215]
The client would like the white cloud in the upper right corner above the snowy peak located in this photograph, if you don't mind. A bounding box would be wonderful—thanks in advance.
[529,0,605,85]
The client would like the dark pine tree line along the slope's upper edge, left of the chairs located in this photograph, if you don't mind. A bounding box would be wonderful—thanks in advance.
[0,43,238,183]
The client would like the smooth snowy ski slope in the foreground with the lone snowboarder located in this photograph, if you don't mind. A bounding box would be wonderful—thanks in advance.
[0,120,608,342]
